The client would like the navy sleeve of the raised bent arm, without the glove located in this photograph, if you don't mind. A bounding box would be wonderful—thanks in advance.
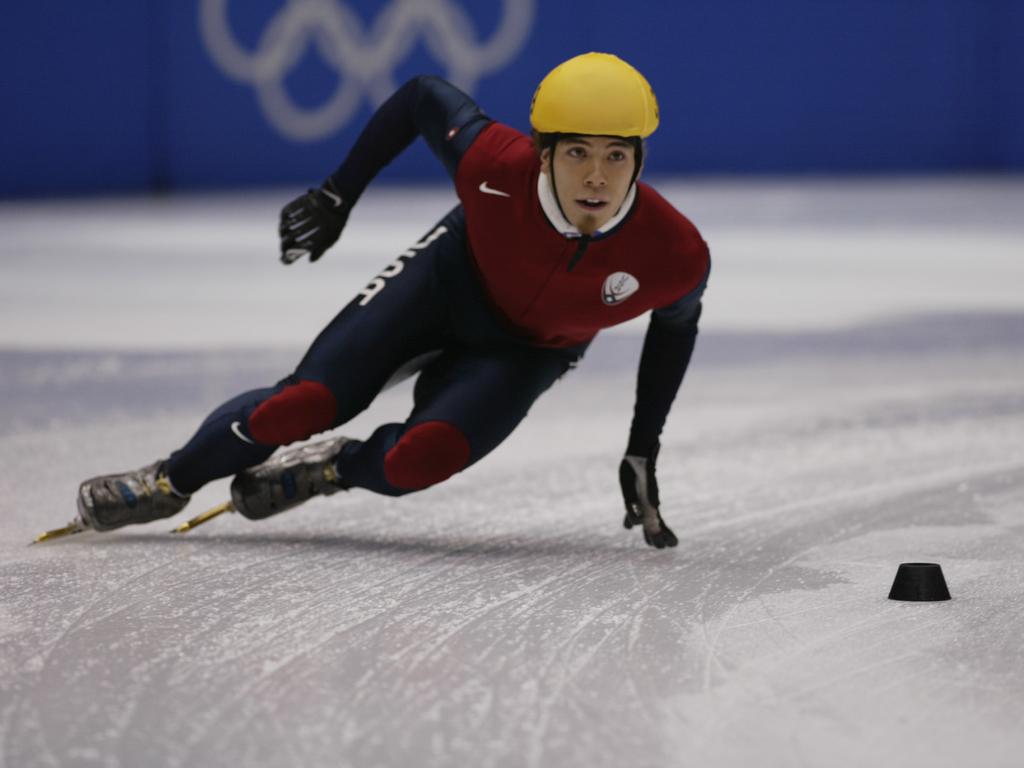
[331,75,492,206]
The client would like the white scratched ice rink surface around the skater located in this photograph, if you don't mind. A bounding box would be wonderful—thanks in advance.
[0,178,1024,768]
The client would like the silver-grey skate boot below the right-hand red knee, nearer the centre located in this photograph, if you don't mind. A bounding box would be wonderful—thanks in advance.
[231,437,349,520]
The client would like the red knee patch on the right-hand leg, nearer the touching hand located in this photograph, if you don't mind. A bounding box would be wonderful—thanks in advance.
[384,421,469,490]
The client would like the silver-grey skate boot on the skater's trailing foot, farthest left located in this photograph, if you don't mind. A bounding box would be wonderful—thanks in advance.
[78,461,189,530]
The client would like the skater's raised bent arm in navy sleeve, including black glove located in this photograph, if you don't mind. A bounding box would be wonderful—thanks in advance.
[279,76,490,264]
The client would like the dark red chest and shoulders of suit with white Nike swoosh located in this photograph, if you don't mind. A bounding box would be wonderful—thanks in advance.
[456,123,710,347]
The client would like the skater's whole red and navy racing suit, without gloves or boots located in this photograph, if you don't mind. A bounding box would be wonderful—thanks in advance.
[167,77,710,496]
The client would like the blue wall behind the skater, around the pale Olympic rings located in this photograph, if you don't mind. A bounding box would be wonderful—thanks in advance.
[0,0,1024,197]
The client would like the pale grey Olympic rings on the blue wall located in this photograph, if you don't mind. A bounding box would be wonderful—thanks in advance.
[200,0,535,141]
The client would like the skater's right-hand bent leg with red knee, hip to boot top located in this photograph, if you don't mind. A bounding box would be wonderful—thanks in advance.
[337,350,569,496]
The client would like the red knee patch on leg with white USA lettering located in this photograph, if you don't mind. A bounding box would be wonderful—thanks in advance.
[249,381,338,445]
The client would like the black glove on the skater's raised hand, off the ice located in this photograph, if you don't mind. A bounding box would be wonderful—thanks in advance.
[278,179,351,264]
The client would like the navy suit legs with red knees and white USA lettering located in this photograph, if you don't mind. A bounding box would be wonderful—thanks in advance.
[168,207,586,496]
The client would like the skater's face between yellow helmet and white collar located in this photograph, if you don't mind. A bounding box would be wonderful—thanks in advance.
[541,136,636,234]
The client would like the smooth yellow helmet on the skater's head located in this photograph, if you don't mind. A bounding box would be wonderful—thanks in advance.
[529,52,658,138]
